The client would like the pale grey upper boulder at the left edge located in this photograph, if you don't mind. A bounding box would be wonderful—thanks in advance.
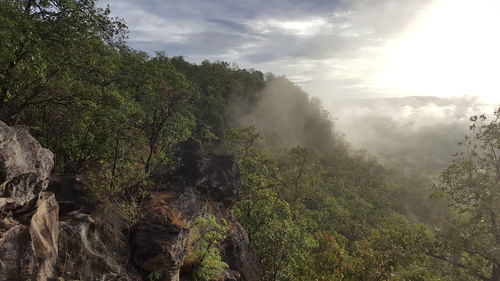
[0,121,54,217]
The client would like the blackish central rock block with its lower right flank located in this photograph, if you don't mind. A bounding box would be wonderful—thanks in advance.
[170,139,259,281]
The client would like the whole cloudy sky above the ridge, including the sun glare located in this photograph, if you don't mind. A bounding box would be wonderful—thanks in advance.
[100,0,500,104]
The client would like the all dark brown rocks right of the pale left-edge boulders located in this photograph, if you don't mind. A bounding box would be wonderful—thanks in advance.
[48,140,259,281]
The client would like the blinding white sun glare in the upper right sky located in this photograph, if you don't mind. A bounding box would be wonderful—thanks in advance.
[370,0,500,102]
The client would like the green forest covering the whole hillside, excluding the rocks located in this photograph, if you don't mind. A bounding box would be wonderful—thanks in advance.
[0,0,500,281]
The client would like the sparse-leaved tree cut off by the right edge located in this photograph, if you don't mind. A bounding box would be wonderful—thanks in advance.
[433,109,500,281]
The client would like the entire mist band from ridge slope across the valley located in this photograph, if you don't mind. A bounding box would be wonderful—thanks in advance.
[231,77,495,176]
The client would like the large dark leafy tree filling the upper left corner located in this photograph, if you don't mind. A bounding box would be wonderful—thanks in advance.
[0,0,125,124]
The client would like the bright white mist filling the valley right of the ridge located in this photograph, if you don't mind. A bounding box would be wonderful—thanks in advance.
[329,97,495,174]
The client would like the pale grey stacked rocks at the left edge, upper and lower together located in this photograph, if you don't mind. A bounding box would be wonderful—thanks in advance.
[0,122,59,281]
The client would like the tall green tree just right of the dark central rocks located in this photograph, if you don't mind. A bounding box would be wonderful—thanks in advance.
[226,127,313,281]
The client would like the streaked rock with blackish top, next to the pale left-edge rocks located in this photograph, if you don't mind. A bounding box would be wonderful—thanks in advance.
[47,174,141,281]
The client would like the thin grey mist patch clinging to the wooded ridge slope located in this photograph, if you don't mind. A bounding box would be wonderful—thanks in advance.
[232,77,344,151]
